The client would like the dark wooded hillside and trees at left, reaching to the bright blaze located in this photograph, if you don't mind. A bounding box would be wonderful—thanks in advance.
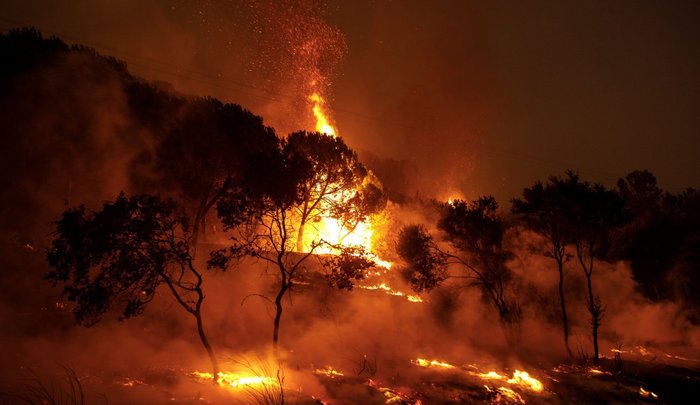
[0,29,386,379]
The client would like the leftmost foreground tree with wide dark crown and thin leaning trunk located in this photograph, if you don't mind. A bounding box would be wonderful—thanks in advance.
[45,193,219,382]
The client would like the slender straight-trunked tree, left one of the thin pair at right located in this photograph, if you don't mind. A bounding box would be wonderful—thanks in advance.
[512,172,577,356]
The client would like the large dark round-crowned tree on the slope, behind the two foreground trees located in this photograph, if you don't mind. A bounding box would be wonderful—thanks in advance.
[144,98,278,245]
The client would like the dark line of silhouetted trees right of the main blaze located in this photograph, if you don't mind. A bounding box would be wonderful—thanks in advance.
[397,171,700,360]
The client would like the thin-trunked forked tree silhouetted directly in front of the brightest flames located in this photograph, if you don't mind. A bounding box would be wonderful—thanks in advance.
[209,138,374,358]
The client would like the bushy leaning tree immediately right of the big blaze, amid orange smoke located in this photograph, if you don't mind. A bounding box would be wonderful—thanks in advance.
[398,197,520,325]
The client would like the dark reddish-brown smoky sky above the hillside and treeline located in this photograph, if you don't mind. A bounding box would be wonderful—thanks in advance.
[0,0,700,200]
